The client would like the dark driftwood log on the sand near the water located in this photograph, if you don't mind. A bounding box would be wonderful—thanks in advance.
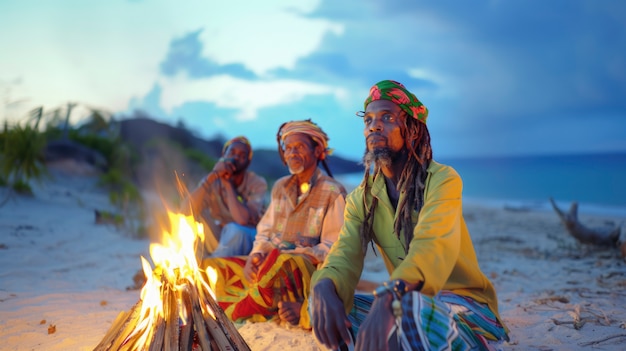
[550,198,624,248]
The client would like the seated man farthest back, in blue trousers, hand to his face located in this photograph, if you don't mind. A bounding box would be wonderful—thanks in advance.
[181,136,267,257]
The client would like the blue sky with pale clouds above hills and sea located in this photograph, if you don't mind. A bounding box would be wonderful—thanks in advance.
[0,0,626,160]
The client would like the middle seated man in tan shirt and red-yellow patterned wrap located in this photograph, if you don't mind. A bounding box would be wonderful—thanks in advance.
[202,120,346,329]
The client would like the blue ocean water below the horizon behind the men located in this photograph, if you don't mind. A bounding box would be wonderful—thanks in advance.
[334,153,626,218]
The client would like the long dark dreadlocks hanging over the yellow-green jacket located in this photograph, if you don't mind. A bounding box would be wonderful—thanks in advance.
[360,114,433,254]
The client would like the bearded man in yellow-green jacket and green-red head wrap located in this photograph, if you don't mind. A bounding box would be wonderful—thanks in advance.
[310,80,508,351]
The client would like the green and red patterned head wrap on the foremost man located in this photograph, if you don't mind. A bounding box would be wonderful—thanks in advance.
[363,80,428,124]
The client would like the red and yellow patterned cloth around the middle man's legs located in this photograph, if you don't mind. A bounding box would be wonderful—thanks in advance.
[202,249,315,327]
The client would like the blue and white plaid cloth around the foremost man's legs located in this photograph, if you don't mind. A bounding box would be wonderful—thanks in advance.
[348,291,508,350]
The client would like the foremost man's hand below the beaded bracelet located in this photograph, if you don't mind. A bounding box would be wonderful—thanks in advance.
[354,293,394,351]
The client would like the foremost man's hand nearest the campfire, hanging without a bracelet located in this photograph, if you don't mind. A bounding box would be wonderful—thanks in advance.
[310,279,352,350]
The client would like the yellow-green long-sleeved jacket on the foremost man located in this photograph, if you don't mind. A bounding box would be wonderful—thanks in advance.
[311,161,502,323]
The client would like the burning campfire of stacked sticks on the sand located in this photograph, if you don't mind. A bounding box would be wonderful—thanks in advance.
[94,213,250,351]
